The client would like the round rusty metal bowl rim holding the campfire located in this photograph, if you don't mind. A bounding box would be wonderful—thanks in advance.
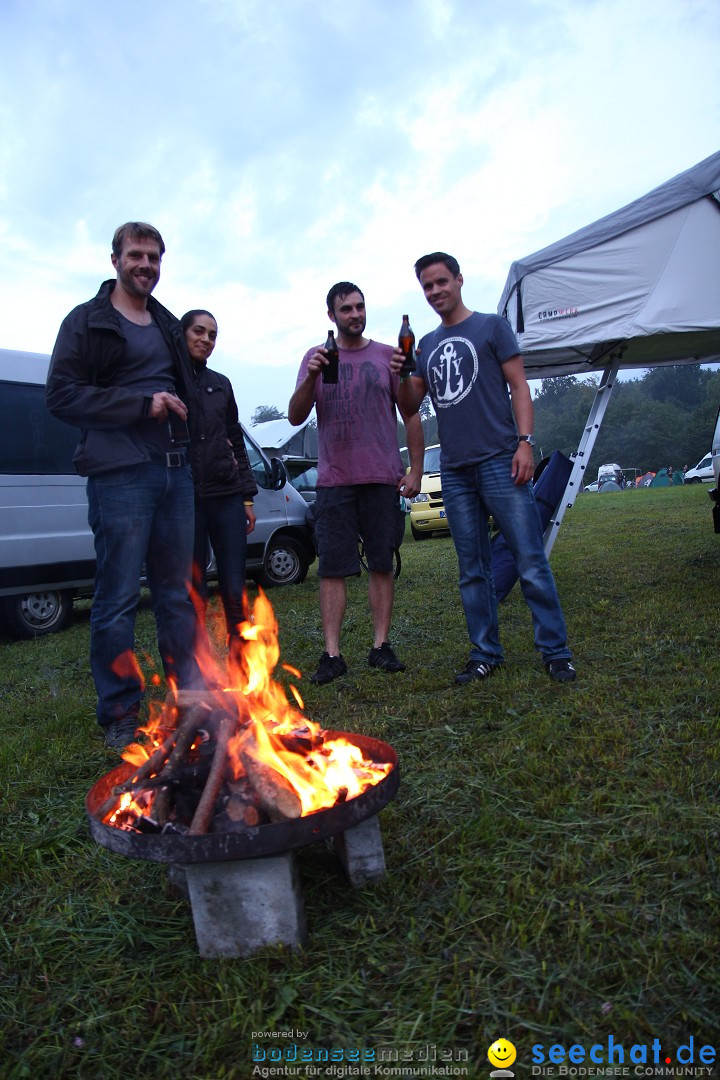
[85,731,400,864]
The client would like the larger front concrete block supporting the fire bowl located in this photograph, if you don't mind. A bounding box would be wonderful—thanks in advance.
[185,851,307,957]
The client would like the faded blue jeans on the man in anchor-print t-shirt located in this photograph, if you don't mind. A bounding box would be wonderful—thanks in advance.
[441,454,571,664]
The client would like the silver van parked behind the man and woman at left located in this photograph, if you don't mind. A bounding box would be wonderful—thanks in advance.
[0,349,315,637]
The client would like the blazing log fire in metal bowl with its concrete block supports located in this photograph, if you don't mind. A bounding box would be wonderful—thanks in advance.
[86,593,399,956]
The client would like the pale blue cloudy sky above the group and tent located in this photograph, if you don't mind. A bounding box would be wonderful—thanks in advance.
[0,0,720,422]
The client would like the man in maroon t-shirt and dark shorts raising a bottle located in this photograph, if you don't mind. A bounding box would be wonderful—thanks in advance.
[287,282,423,683]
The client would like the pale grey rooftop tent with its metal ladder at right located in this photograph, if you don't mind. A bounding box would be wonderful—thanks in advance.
[498,153,720,550]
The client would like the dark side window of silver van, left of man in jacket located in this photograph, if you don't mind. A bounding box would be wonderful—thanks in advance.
[0,382,80,475]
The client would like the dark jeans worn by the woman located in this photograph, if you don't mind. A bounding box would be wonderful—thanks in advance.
[192,495,247,637]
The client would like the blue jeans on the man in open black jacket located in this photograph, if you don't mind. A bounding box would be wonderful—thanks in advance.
[87,462,203,727]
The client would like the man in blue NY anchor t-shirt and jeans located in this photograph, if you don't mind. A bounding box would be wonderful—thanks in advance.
[392,252,575,684]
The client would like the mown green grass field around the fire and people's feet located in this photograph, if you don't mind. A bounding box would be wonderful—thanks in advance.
[0,486,720,1080]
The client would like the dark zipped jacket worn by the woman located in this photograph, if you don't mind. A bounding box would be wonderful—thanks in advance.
[190,364,258,501]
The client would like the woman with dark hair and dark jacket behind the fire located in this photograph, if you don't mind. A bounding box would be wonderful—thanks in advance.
[180,310,257,659]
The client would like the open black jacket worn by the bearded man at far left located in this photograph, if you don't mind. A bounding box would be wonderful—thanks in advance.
[45,279,198,476]
